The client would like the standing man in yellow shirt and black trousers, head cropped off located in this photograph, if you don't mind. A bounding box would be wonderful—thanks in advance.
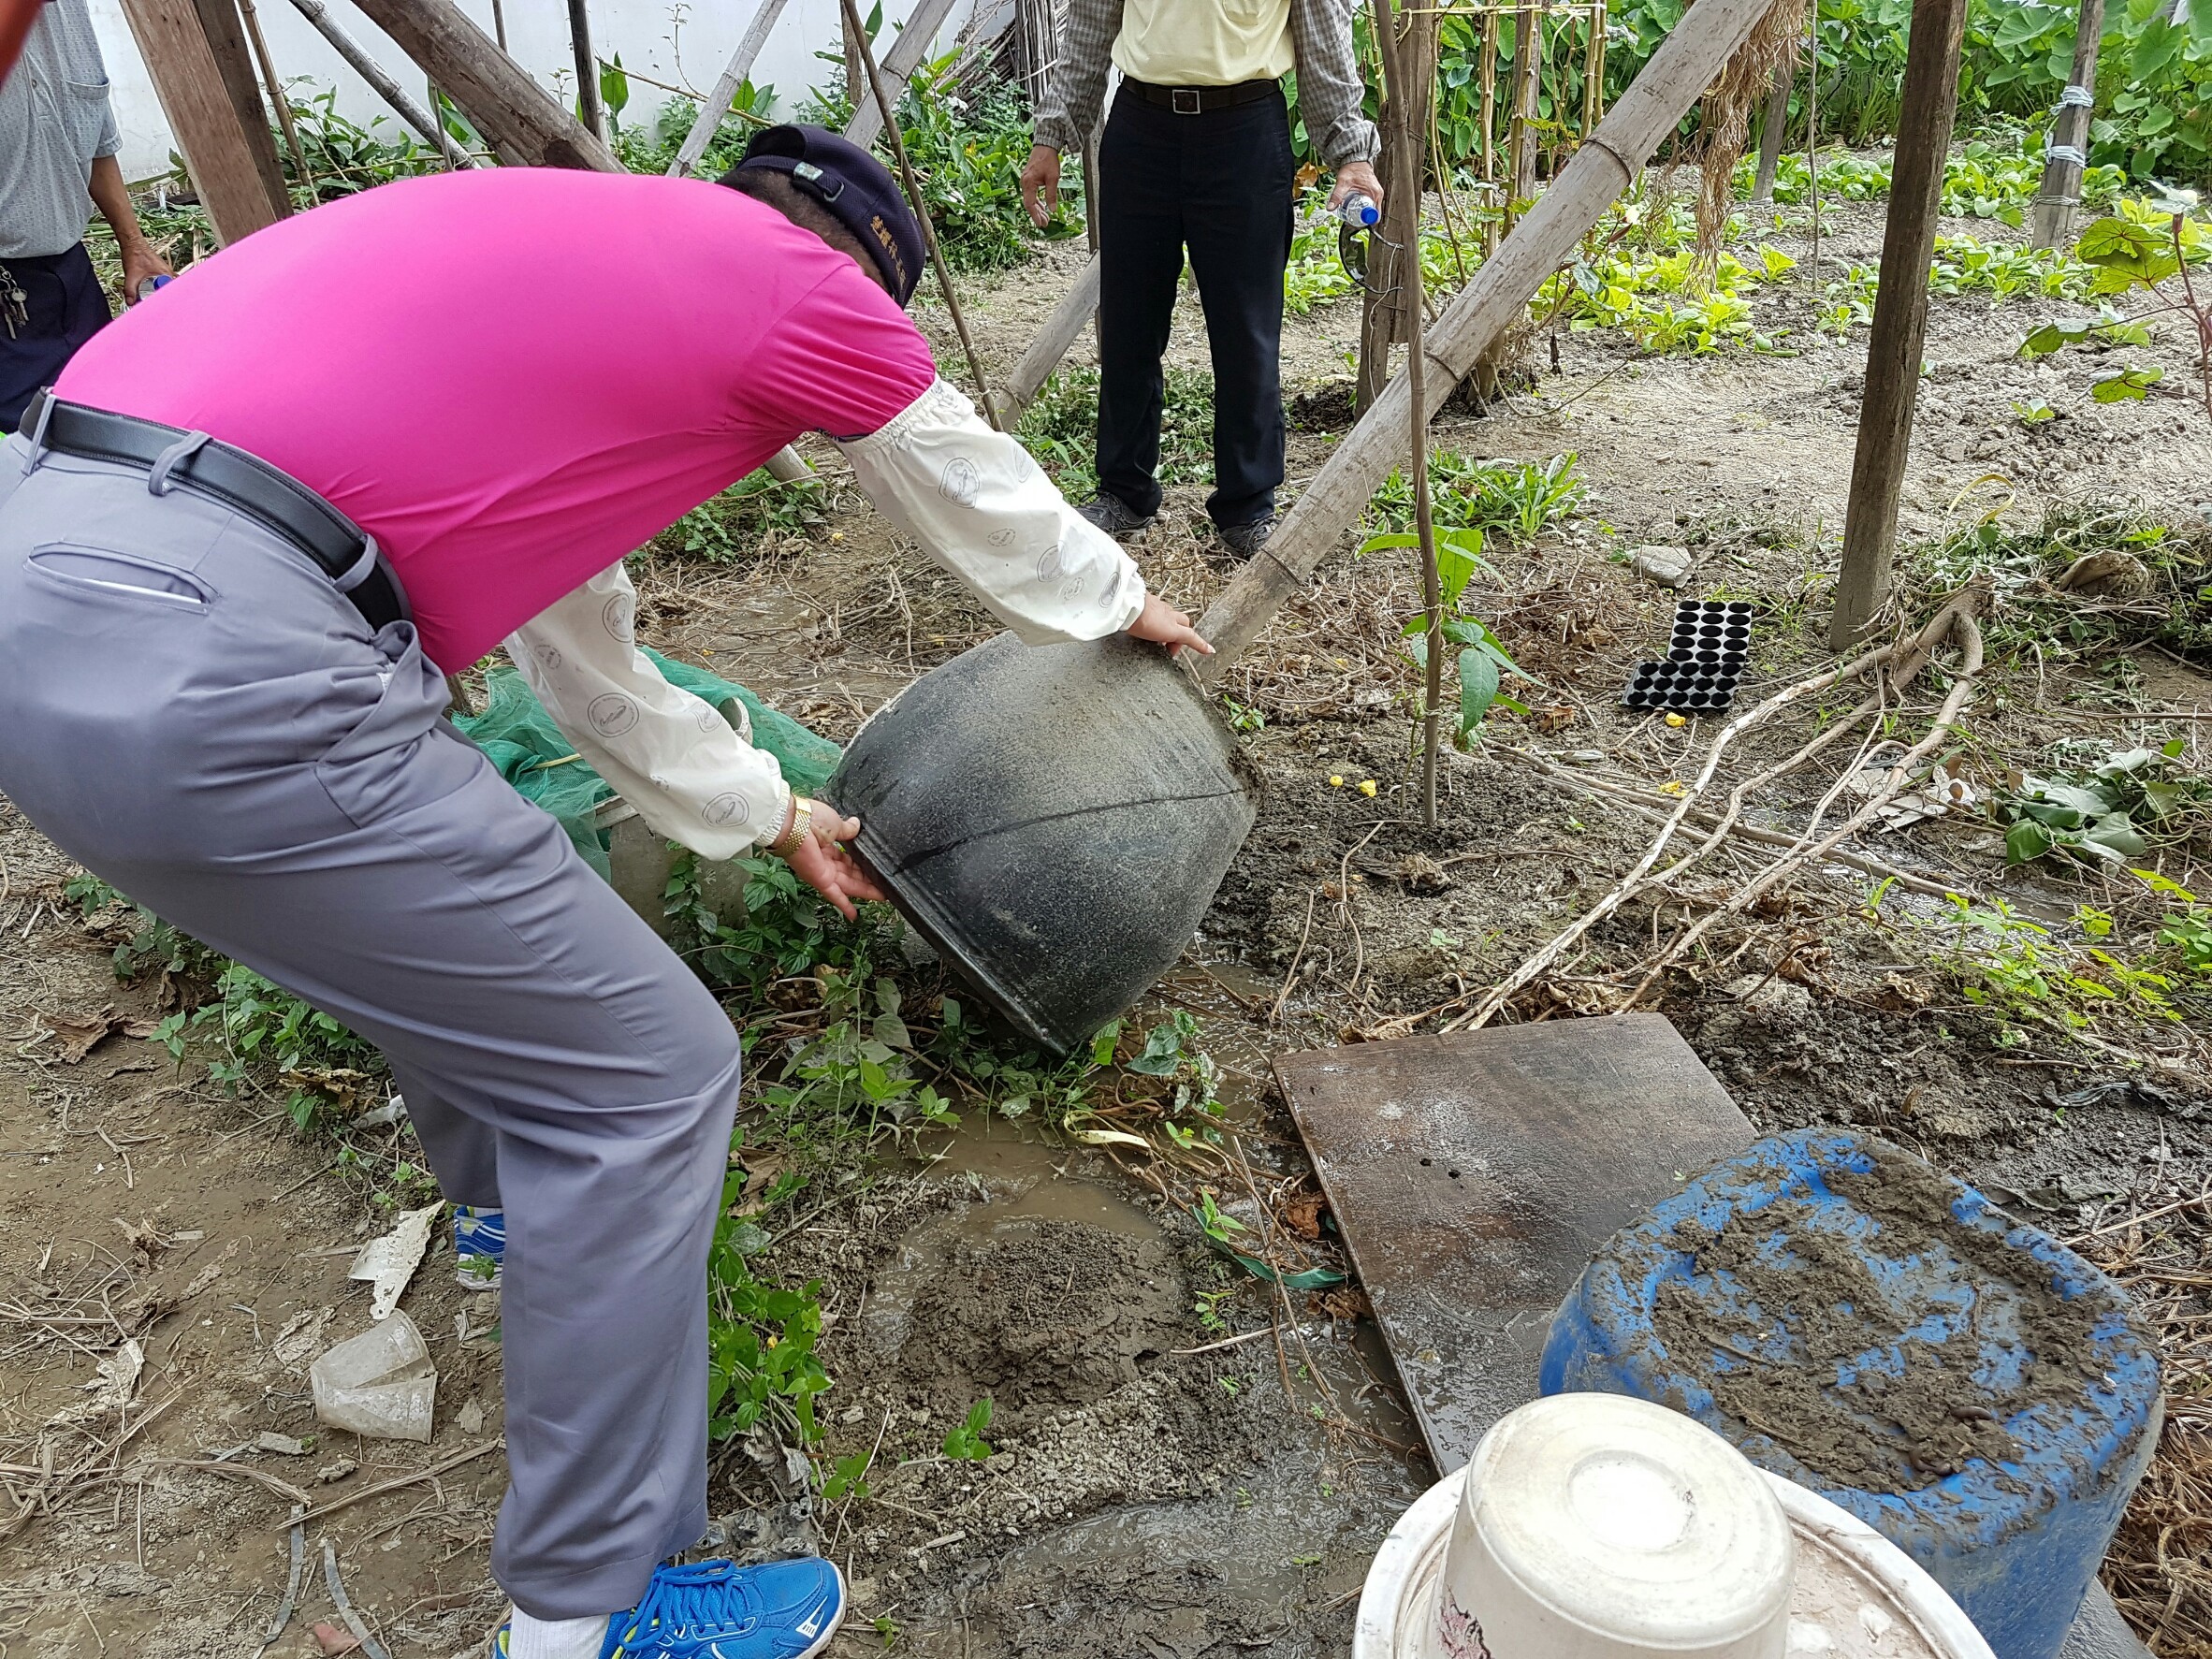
[1022,0,1383,558]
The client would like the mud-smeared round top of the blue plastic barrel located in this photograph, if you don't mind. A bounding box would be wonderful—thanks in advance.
[1646,1143,2139,1493]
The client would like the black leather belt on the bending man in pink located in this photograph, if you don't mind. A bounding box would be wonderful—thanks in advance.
[16,391,407,628]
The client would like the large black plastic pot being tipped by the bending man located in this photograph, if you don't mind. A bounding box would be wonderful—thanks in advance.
[825,634,1254,1055]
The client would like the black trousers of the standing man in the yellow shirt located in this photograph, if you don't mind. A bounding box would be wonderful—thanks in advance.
[1098,89,1296,529]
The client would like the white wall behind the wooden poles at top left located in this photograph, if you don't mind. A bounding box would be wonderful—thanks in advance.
[91,0,968,179]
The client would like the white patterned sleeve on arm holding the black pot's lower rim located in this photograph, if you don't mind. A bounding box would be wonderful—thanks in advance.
[506,564,792,858]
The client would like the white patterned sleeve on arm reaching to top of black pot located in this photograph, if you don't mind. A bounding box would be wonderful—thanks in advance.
[837,381,1143,646]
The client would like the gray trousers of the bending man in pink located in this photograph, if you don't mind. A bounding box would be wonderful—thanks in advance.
[0,438,739,1619]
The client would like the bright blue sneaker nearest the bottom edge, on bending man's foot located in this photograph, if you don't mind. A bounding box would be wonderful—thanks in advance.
[491,1557,845,1659]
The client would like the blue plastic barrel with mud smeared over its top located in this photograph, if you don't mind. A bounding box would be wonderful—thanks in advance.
[1542,1130,2161,1659]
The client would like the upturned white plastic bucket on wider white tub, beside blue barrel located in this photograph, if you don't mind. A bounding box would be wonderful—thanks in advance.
[1351,1393,1993,1659]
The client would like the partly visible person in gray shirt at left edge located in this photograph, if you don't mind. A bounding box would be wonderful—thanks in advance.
[0,0,170,431]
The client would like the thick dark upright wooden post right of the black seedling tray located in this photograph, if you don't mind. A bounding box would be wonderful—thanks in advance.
[1829,0,1967,650]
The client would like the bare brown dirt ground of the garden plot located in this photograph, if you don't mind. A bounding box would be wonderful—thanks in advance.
[0,175,2212,1659]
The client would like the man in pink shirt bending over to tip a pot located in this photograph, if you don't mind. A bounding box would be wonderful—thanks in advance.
[0,126,1208,1659]
